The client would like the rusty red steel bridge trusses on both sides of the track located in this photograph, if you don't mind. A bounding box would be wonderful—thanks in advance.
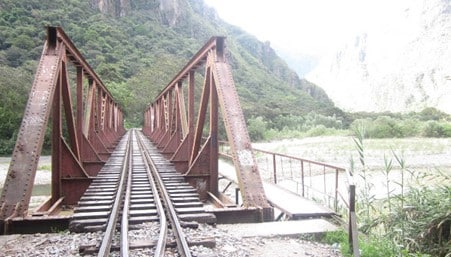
[0,27,356,256]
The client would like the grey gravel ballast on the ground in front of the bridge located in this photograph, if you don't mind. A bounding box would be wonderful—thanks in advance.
[0,224,341,257]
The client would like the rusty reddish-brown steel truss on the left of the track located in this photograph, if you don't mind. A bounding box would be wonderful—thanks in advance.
[0,27,125,223]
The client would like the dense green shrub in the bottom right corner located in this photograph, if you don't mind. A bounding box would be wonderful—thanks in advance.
[385,183,451,256]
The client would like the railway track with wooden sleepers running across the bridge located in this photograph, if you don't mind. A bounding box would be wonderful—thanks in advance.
[69,129,216,256]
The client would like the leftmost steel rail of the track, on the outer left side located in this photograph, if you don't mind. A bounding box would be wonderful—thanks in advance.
[97,132,132,257]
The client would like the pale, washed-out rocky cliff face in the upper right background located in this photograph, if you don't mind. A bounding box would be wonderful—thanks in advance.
[307,0,451,113]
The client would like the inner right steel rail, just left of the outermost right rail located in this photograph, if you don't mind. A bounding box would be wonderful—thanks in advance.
[135,128,168,257]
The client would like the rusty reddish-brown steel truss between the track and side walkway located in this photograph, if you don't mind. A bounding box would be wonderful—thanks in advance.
[143,37,273,220]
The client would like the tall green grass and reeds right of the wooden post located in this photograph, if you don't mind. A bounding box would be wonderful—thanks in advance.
[342,123,451,257]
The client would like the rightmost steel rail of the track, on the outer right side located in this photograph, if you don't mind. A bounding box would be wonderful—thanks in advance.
[137,132,191,257]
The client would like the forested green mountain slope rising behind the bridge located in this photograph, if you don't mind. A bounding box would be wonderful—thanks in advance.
[0,0,344,153]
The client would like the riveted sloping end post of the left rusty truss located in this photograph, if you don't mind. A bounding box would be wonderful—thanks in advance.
[0,38,64,220]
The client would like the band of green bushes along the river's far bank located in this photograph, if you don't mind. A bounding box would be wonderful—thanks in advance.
[248,108,451,141]
